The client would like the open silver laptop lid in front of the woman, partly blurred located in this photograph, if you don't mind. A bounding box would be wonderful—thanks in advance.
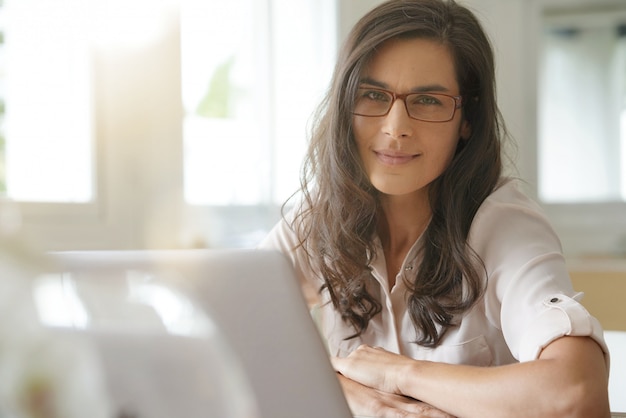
[39,250,351,418]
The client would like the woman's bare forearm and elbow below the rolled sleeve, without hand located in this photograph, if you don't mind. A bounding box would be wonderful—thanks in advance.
[397,338,609,417]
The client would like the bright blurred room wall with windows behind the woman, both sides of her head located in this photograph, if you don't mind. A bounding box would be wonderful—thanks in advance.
[0,0,626,258]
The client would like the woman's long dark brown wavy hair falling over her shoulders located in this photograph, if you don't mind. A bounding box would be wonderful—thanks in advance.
[292,0,504,347]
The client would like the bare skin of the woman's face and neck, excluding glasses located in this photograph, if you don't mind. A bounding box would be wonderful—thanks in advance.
[353,39,470,287]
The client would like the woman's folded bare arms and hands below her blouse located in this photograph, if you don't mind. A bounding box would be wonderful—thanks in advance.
[332,337,610,418]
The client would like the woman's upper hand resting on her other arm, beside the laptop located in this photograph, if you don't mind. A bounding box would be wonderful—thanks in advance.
[331,345,415,395]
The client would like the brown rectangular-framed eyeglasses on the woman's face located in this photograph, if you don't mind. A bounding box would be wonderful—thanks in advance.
[352,87,462,122]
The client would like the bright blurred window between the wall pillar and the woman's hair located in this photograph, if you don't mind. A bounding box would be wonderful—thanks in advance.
[181,0,336,246]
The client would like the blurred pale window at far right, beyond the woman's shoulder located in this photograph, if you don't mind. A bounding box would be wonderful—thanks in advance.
[539,8,626,203]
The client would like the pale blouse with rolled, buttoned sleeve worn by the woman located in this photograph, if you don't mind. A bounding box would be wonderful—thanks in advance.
[260,179,608,366]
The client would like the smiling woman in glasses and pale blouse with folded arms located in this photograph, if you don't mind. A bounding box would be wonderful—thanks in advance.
[261,0,609,417]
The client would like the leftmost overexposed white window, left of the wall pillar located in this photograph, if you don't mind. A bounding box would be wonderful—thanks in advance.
[0,0,94,202]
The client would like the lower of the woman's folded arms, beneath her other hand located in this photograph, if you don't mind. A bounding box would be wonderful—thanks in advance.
[338,374,453,418]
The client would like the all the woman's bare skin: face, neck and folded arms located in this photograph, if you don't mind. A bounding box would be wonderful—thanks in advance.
[332,39,610,418]
